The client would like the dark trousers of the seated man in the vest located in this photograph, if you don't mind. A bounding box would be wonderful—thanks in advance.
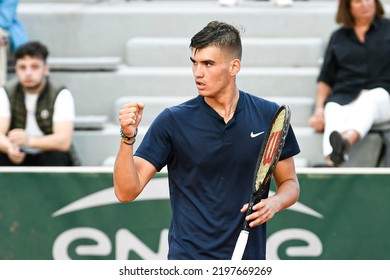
[0,151,71,166]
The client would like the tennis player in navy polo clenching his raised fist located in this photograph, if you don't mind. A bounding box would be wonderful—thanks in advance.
[114,21,300,260]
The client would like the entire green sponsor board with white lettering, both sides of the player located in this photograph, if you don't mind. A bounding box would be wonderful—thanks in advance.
[0,167,390,260]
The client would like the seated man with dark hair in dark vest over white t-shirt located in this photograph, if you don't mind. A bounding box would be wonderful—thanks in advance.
[0,42,75,166]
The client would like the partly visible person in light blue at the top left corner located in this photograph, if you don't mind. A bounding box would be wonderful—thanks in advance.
[0,0,28,86]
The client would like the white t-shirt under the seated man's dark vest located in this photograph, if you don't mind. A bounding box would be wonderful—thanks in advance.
[0,88,76,153]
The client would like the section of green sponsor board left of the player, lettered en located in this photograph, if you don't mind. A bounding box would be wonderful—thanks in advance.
[0,169,170,260]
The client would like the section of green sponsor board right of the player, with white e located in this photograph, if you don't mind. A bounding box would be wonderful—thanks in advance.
[267,168,390,260]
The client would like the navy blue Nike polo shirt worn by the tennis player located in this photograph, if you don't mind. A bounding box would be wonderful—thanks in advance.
[135,91,300,260]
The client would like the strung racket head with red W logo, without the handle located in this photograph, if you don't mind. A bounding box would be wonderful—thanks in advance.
[252,104,291,199]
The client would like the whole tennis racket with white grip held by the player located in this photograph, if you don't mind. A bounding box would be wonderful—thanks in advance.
[232,105,291,260]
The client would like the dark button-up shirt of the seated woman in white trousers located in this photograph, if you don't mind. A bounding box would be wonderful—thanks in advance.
[318,18,390,105]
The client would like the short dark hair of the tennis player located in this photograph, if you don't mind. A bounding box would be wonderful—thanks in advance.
[190,21,242,59]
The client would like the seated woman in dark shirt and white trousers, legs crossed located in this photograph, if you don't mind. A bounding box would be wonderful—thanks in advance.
[309,0,390,166]
